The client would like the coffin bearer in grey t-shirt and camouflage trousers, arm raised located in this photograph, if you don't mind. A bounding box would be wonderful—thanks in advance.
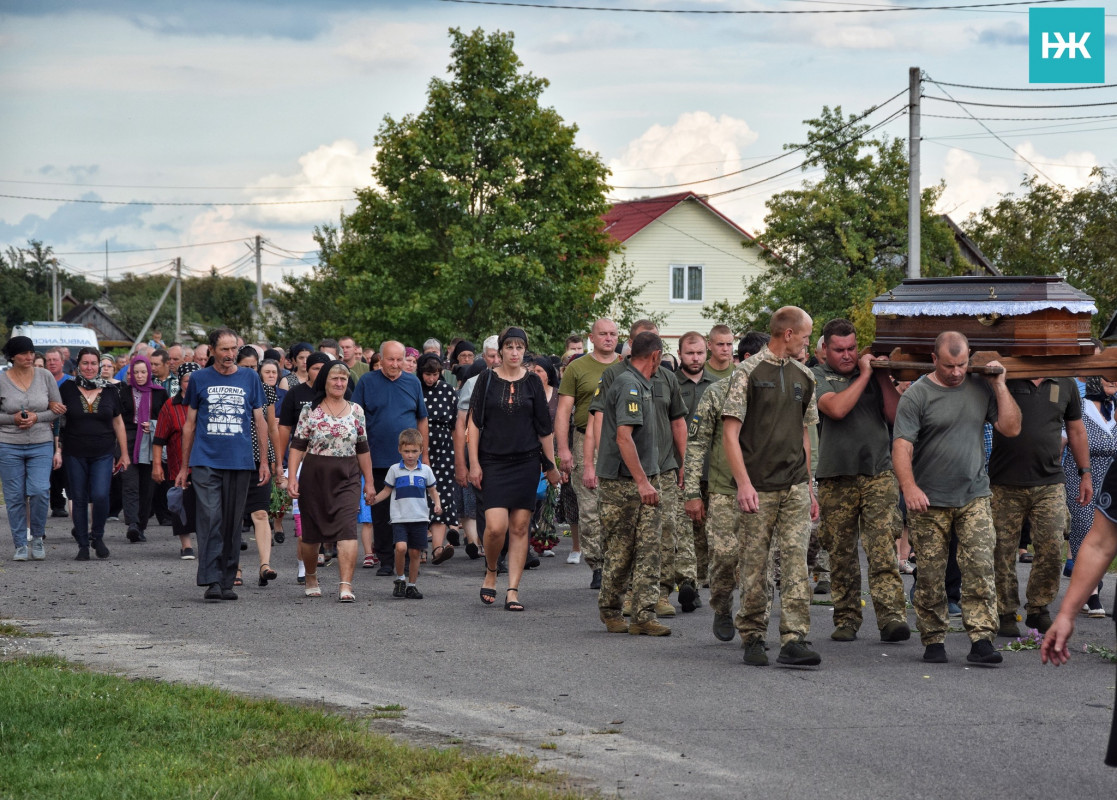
[892,331,1020,666]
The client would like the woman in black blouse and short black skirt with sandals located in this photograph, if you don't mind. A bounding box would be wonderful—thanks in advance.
[468,327,559,611]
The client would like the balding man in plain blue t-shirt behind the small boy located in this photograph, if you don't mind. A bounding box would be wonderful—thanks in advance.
[353,342,430,575]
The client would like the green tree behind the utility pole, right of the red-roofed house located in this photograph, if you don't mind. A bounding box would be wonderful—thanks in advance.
[703,106,966,342]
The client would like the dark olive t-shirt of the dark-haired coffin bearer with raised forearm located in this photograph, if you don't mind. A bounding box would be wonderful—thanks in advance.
[814,363,892,478]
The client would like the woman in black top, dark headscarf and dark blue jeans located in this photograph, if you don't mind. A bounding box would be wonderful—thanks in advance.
[58,347,131,561]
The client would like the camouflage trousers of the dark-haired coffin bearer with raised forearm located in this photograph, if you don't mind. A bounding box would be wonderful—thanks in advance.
[819,469,907,630]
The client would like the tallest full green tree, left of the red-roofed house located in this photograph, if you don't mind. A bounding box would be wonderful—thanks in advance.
[283,29,614,347]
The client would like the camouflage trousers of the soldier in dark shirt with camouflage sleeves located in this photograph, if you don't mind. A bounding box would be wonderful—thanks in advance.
[732,483,811,645]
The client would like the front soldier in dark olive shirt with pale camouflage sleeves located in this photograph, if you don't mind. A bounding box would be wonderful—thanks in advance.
[722,306,822,666]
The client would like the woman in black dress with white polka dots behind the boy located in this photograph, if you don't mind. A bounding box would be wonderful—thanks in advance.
[417,353,458,564]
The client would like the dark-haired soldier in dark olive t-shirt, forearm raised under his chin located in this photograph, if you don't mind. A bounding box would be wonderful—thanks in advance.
[814,320,911,641]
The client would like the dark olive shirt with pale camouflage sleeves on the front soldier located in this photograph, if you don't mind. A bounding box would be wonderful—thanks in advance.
[722,346,819,492]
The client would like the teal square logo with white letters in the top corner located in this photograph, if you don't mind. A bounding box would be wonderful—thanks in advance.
[1028,8,1106,84]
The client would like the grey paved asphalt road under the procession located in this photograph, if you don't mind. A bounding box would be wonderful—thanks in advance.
[0,511,1117,800]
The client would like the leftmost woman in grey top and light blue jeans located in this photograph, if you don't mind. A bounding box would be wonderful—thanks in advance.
[0,336,66,561]
